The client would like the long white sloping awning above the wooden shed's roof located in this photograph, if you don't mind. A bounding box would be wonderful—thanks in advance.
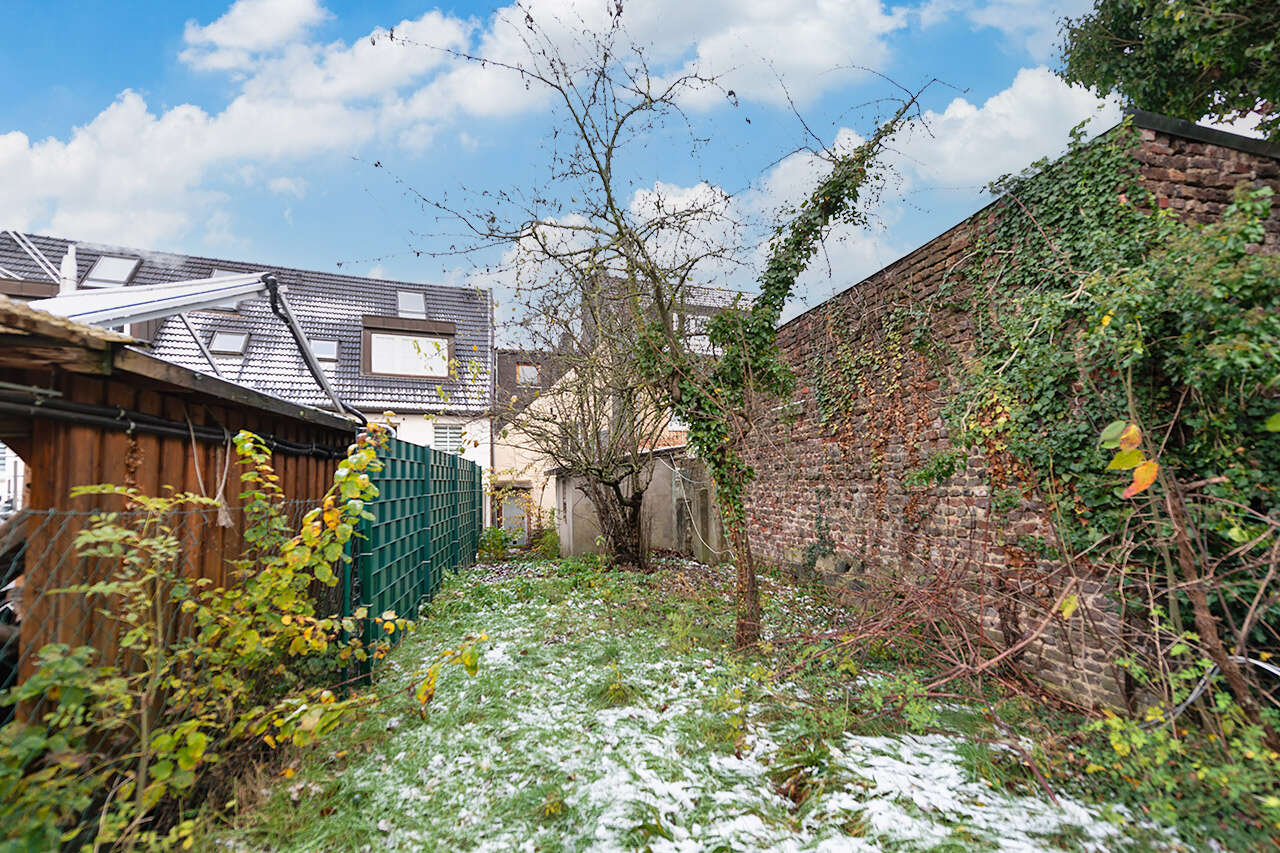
[29,273,284,327]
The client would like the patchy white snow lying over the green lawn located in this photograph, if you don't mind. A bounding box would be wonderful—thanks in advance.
[232,558,1177,853]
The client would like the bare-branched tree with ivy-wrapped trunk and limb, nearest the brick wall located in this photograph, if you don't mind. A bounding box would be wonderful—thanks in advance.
[384,3,918,630]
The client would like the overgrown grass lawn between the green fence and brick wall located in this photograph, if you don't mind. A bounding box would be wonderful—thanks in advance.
[206,561,1172,852]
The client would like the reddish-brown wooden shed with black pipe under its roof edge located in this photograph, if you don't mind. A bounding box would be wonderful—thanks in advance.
[0,297,358,688]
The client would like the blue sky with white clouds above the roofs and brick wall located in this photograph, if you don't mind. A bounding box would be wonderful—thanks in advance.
[0,0,1119,315]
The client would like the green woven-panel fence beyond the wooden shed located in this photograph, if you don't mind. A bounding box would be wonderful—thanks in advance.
[347,438,484,640]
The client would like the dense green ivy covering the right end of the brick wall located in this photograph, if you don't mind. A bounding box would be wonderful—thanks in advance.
[946,116,1280,827]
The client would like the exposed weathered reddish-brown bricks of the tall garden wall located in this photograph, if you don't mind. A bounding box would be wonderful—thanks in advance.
[749,117,1280,706]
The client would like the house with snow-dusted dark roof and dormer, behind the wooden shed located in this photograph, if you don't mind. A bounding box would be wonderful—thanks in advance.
[0,231,493,514]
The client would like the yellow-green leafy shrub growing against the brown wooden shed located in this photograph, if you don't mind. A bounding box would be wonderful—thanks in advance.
[0,432,476,849]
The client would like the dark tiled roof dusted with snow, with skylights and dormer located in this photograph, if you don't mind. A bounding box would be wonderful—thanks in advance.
[0,232,490,414]
